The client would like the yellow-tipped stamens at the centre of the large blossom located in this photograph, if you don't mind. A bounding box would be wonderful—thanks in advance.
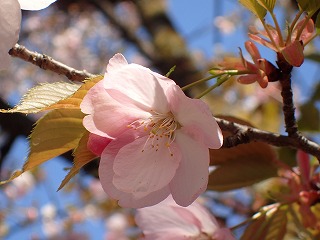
[128,110,181,156]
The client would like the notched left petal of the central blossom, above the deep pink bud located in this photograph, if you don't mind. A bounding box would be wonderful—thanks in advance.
[80,81,150,138]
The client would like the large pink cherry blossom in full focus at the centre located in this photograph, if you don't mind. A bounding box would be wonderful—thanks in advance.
[80,54,223,208]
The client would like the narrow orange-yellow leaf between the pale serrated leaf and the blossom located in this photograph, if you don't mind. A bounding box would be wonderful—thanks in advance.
[45,76,103,110]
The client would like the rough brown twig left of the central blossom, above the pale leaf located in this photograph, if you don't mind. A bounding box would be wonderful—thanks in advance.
[9,44,96,81]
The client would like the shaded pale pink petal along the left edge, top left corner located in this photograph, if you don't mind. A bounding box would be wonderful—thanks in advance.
[0,0,21,70]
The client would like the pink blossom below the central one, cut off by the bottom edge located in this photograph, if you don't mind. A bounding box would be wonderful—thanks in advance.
[135,196,235,240]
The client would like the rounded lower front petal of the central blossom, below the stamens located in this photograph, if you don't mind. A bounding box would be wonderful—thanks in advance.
[113,134,181,198]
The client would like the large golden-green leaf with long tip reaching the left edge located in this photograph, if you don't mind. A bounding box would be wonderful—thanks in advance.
[0,109,85,184]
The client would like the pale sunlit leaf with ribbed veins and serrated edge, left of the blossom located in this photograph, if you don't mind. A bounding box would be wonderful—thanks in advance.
[0,82,81,113]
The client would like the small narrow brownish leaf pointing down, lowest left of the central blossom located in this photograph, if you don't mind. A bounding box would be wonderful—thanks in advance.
[58,131,97,190]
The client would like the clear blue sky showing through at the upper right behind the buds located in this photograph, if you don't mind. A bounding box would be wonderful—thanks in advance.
[168,0,320,101]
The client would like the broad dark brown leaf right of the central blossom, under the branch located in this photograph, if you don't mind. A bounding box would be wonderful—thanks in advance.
[208,116,277,191]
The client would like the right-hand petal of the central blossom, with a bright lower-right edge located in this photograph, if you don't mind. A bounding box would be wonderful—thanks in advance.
[166,85,223,149]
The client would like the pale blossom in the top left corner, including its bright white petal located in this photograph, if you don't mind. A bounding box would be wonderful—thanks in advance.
[0,0,56,70]
